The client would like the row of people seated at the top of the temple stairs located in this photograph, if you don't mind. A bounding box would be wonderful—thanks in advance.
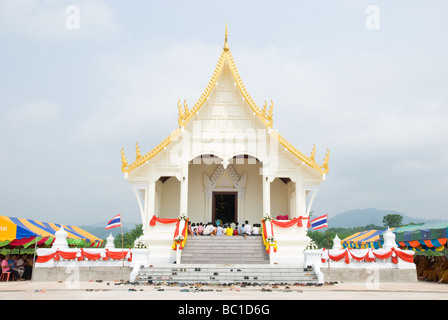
[188,220,261,238]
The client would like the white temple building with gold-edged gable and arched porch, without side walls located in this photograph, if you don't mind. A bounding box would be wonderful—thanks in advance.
[121,25,329,260]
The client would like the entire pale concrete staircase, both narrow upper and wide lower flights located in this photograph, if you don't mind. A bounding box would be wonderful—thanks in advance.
[135,236,318,284]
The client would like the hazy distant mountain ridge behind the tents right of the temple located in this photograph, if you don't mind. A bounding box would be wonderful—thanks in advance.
[328,208,446,228]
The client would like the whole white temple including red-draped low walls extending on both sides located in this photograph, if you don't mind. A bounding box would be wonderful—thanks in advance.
[34,25,417,288]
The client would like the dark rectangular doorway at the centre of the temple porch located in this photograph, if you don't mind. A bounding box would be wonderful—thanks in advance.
[212,192,238,223]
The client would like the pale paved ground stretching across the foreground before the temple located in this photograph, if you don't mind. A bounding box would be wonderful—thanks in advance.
[0,281,448,301]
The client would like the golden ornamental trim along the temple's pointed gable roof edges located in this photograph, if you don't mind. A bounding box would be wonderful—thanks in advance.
[121,23,329,174]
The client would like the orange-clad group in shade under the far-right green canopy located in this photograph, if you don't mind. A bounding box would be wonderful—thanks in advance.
[414,255,448,283]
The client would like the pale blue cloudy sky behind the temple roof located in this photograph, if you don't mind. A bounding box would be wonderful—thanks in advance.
[0,0,448,225]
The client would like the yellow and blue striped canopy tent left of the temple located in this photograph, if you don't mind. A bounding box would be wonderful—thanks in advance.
[0,216,103,248]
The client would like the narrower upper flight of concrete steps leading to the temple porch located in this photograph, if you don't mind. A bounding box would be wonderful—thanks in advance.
[181,236,269,264]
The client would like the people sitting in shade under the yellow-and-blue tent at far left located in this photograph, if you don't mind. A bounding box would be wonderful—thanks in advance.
[0,254,33,281]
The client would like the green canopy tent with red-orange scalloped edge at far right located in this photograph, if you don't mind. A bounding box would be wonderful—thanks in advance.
[393,222,448,251]
